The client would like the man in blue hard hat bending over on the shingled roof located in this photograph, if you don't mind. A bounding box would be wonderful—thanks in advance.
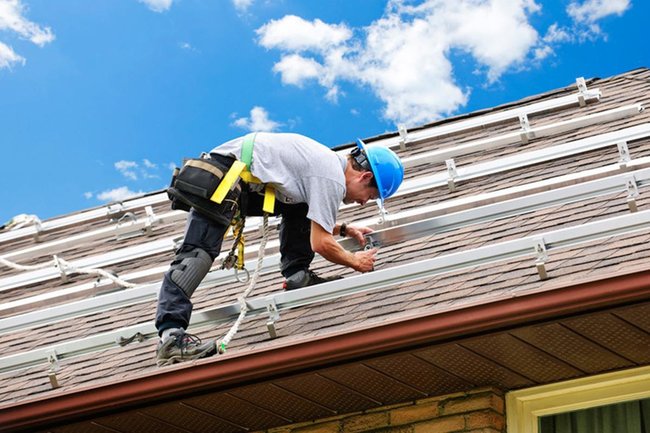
[156,132,404,365]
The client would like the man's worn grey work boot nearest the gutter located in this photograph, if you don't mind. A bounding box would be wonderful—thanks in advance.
[156,329,217,367]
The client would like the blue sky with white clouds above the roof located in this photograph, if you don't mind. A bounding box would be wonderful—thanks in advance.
[0,0,650,223]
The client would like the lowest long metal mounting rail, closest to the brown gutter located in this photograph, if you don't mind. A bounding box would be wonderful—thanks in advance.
[0,211,650,372]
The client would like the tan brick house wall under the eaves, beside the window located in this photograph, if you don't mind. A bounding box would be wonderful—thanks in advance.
[256,388,506,433]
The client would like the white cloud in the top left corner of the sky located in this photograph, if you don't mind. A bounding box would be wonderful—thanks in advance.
[0,0,54,69]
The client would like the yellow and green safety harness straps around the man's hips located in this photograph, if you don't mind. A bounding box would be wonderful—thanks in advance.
[210,134,275,214]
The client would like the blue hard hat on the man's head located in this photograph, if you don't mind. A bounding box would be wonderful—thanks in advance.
[353,138,404,205]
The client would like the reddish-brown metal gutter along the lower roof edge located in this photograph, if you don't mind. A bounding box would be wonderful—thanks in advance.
[0,269,650,431]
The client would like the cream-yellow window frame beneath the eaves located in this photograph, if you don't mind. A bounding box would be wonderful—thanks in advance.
[506,366,650,433]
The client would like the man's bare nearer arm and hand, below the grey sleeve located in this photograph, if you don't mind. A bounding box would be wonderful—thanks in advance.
[310,221,377,272]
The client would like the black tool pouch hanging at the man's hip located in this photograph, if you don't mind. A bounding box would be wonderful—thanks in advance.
[167,159,241,225]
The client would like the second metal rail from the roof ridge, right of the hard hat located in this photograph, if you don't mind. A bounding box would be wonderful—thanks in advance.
[402,104,643,167]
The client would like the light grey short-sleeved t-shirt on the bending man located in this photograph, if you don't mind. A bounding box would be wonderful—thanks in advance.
[210,132,347,233]
